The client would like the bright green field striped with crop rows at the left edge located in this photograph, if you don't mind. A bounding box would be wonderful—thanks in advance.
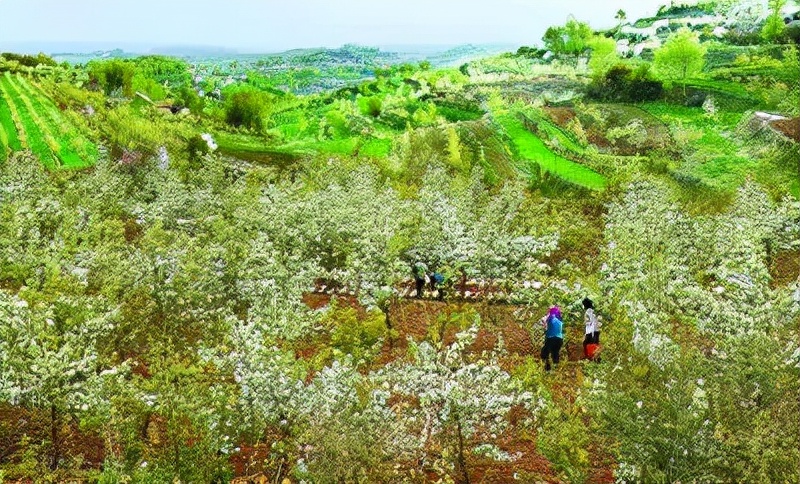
[0,72,98,169]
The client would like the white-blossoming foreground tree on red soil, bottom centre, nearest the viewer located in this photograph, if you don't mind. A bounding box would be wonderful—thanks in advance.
[371,324,534,482]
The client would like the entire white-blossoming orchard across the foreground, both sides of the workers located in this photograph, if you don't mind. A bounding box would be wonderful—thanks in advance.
[0,138,800,482]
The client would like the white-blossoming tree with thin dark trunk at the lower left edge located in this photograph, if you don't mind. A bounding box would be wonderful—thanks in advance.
[0,290,125,470]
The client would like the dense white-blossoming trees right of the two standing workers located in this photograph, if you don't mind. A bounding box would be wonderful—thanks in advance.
[589,182,800,481]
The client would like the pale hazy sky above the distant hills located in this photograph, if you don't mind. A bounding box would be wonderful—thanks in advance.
[0,0,668,50]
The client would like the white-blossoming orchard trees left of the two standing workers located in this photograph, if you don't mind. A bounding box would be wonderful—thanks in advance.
[0,150,556,482]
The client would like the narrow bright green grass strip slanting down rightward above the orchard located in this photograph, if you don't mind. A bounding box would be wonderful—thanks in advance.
[497,115,608,190]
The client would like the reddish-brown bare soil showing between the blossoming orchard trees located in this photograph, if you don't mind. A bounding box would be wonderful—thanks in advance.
[0,292,612,484]
